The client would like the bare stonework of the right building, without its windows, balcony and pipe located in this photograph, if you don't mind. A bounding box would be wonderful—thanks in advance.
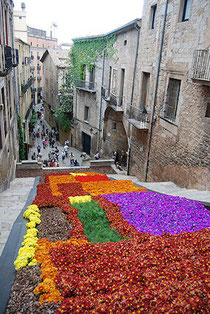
[131,0,210,190]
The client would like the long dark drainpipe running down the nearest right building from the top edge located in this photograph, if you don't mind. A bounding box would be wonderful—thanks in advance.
[145,0,168,181]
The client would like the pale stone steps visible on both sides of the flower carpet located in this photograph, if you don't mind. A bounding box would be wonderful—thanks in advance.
[0,166,210,255]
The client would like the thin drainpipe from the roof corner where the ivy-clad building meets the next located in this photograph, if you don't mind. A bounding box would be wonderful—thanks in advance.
[127,23,140,176]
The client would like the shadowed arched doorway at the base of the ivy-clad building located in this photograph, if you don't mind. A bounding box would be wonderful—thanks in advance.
[102,107,128,167]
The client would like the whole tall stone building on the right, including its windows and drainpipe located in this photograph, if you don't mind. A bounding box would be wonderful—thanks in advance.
[130,0,210,190]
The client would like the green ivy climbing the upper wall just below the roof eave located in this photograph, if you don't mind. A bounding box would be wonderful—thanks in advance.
[71,35,117,82]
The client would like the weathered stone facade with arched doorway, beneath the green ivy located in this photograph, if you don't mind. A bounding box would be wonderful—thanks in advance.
[73,19,140,157]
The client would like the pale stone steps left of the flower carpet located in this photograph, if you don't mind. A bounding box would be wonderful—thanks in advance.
[0,178,35,255]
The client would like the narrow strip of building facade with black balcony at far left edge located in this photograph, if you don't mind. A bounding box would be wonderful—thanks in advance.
[0,0,18,192]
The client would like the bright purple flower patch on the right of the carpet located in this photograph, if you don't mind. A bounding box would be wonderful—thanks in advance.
[102,192,210,235]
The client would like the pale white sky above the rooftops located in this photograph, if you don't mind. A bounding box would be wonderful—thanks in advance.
[13,0,144,44]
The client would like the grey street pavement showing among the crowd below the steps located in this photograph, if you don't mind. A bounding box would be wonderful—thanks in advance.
[28,104,83,167]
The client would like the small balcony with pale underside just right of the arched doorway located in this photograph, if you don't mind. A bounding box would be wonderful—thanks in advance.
[126,105,149,131]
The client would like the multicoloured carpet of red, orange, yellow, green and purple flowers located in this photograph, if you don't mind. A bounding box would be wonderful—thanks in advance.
[8,172,210,313]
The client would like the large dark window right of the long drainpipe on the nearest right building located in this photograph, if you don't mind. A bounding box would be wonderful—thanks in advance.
[164,78,181,121]
